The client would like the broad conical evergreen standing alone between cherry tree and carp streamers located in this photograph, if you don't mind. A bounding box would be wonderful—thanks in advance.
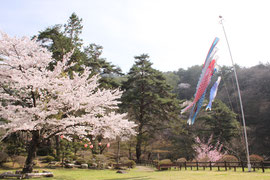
[121,54,179,161]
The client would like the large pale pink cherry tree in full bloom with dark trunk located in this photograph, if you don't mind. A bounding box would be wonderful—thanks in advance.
[0,32,136,172]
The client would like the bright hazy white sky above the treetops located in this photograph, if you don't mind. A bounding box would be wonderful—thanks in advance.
[0,0,270,72]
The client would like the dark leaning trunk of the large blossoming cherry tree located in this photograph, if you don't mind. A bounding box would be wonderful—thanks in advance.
[23,131,40,173]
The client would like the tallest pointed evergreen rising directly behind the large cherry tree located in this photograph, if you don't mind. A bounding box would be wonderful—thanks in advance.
[38,13,85,72]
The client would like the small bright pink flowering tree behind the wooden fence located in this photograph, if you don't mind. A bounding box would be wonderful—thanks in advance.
[194,135,226,162]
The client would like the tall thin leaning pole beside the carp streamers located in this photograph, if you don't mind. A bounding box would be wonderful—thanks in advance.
[219,16,251,172]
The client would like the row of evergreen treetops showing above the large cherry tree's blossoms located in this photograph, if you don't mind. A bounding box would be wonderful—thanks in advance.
[37,13,122,88]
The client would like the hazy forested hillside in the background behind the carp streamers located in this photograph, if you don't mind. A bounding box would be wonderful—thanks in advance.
[165,64,270,157]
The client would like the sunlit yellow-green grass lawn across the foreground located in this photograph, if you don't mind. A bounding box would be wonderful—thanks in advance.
[0,166,270,180]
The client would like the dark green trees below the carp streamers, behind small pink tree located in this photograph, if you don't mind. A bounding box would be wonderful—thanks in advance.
[171,99,238,160]
